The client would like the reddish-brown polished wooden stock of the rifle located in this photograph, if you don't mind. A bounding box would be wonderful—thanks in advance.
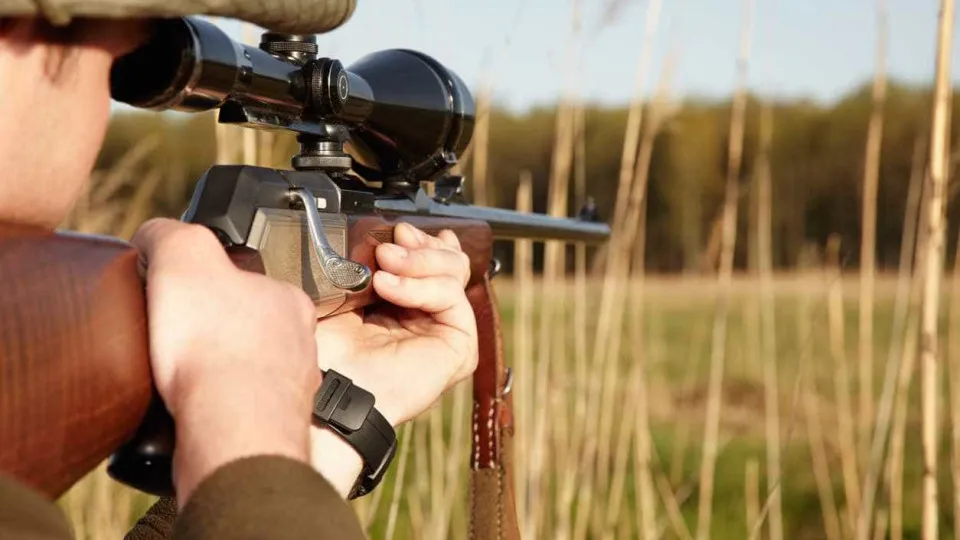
[0,216,502,498]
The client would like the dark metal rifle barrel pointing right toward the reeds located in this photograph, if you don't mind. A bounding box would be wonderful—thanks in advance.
[375,196,610,244]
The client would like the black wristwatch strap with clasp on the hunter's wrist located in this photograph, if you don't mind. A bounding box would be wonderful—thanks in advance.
[313,369,397,499]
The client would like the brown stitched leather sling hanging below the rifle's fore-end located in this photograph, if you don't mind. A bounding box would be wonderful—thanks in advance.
[467,274,520,540]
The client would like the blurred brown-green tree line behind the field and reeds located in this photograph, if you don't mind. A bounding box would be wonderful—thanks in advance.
[97,79,960,272]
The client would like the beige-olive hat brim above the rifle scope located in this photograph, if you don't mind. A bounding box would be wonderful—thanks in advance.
[0,0,357,34]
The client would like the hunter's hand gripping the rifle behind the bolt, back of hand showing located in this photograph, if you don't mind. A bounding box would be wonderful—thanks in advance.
[132,219,320,505]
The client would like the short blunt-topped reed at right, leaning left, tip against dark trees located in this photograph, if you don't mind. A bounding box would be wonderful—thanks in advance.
[827,236,860,527]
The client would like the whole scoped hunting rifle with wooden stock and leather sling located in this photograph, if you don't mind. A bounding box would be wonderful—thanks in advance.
[0,18,610,539]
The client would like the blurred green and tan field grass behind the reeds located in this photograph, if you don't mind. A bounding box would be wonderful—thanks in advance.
[61,274,953,540]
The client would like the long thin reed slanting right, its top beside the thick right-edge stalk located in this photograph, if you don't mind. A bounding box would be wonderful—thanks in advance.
[856,136,923,540]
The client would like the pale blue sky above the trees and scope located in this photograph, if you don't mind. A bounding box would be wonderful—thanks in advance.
[210,0,960,109]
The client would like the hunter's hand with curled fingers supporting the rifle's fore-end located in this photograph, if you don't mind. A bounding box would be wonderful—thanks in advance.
[316,223,477,426]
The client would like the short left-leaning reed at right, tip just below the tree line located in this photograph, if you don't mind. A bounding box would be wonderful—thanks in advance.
[797,288,843,540]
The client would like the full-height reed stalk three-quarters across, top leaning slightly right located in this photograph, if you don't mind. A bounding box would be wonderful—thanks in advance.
[697,0,753,540]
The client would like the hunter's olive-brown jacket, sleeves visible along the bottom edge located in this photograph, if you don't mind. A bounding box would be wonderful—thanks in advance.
[0,456,365,540]
